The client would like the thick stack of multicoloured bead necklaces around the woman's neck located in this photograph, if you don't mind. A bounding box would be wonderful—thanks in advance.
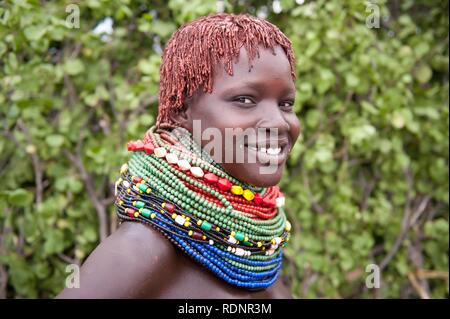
[115,127,291,289]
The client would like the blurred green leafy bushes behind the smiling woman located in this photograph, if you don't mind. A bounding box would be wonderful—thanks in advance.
[0,0,449,298]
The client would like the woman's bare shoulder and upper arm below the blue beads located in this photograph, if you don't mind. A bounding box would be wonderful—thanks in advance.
[57,222,177,298]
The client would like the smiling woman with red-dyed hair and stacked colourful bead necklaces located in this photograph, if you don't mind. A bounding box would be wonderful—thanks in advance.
[58,14,300,298]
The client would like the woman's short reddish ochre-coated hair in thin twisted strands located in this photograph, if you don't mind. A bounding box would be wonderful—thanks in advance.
[156,13,295,128]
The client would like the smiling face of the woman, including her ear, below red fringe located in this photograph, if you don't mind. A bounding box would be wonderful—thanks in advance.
[176,47,300,187]
